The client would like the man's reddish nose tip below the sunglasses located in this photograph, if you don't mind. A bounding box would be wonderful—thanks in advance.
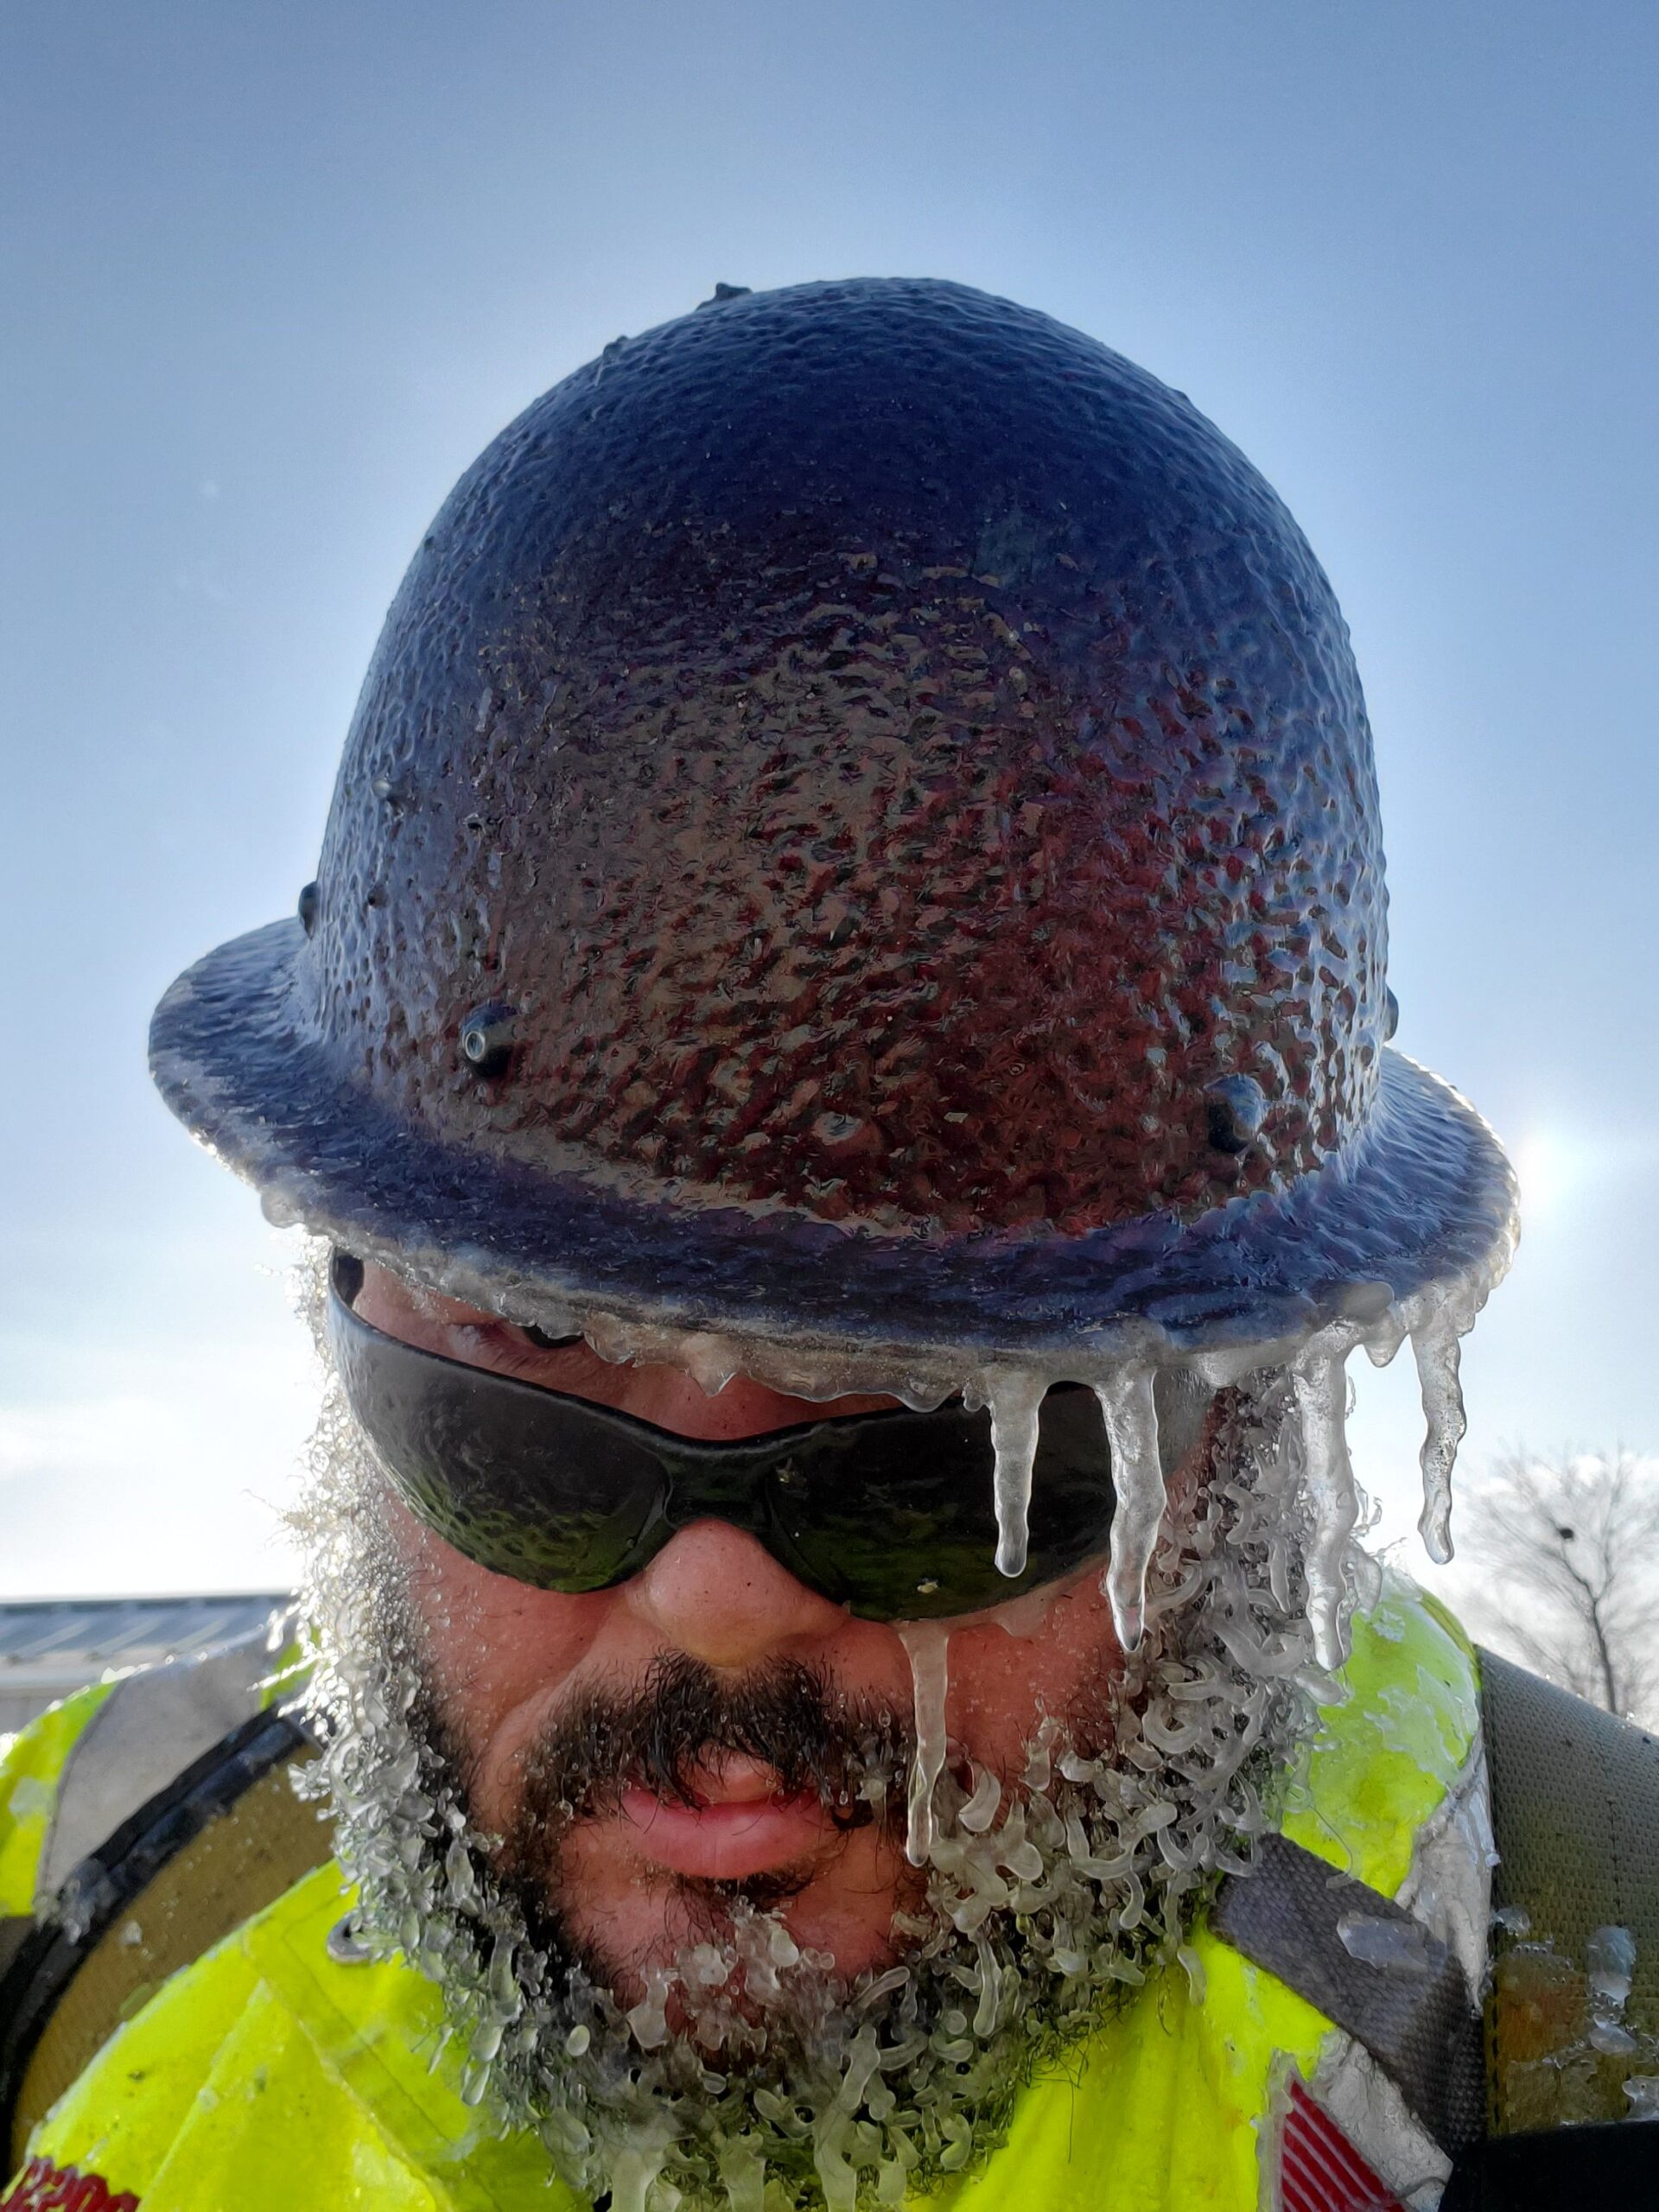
[626,1520,847,1670]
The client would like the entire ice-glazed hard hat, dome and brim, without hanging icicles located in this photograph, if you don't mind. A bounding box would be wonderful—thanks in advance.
[153,281,1513,1433]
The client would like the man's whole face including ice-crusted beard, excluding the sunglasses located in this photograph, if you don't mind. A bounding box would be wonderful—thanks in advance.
[308,1268,1312,2205]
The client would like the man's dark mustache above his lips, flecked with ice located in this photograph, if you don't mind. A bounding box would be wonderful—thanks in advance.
[515,1652,912,1829]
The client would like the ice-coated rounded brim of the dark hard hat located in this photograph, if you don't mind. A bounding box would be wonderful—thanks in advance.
[150,920,1516,1376]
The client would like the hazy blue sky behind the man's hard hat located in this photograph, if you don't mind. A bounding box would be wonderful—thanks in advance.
[0,0,1659,1595]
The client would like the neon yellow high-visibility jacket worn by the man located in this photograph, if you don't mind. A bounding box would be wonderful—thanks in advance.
[0,1580,1486,2212]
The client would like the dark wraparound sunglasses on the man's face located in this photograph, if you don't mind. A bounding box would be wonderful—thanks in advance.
[327,1252,1210,1621]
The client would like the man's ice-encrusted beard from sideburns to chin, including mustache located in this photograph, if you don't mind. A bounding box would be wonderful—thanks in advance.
[303,1376,1327,2212]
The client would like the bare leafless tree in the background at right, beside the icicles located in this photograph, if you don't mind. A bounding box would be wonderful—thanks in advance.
[1458,1449,1659,1723]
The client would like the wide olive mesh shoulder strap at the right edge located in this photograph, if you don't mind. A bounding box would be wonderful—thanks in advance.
[1480,1650,1659,2035]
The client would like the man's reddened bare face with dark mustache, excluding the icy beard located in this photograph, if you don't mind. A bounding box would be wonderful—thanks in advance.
[356,1268,1122,2004]
